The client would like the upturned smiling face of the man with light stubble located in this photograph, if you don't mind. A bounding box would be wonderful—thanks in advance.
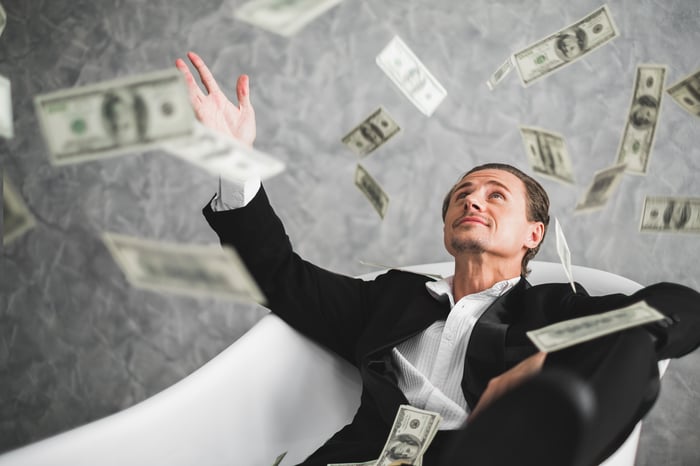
[444,169,544,264]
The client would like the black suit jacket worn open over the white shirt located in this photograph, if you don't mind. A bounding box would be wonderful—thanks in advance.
[203,188,700,464]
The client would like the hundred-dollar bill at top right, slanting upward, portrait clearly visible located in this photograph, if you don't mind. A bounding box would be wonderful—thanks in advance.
[513,5,619,86]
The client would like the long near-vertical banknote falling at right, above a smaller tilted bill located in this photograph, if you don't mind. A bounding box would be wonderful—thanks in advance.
[617,65,666,175]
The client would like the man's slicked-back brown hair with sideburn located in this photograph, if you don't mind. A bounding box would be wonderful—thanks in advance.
[442,163,549,276]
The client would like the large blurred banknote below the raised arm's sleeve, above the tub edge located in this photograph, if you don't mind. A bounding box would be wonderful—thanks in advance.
[102,232,265,304]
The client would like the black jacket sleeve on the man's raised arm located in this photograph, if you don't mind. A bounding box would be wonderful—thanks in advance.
[203,187,373,364]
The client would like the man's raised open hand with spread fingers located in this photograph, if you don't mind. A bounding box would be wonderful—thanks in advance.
[175,52,256,147]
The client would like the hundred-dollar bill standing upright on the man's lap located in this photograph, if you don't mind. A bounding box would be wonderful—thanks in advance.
[376,405,442,466]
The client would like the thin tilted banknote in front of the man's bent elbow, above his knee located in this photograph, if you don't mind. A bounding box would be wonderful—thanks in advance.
[526,301,665,352]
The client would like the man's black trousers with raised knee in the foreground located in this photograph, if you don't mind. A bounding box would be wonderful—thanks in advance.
[302,328,660,466]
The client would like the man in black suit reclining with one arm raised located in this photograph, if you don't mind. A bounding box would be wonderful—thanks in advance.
[176,53,700,466]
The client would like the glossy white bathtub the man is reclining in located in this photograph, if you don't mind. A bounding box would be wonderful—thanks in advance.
[0,261,667,466]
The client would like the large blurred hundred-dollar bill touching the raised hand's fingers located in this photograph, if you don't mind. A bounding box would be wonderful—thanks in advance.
[34,68,195,165]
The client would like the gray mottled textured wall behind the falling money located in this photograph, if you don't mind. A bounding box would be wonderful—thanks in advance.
[0,0,700,465]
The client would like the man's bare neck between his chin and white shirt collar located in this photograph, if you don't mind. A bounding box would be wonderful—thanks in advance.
[452,256,520,303]
